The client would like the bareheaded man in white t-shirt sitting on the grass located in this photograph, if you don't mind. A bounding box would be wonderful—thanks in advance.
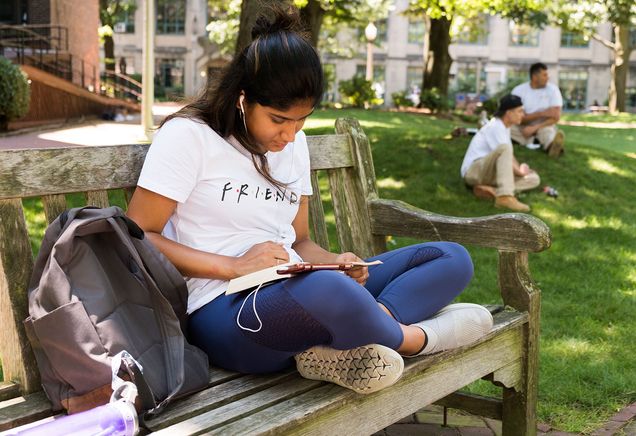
[510,62,565,157]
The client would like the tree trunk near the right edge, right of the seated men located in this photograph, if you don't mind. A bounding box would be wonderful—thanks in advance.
[609,24,632,113]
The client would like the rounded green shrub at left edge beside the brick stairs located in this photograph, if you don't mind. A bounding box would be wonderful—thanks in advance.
[0,57,31,131]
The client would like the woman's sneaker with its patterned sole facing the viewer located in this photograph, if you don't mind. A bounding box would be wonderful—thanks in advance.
[295,344,404,394]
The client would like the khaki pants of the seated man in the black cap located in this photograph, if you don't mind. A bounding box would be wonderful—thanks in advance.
[464,144,541,196]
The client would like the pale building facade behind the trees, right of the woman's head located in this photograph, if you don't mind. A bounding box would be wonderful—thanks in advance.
[323,0,636,110]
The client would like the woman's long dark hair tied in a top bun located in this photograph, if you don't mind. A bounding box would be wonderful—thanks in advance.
[160,6,324,187]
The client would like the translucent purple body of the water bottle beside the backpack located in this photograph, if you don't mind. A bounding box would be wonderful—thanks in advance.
[5,401,139,436]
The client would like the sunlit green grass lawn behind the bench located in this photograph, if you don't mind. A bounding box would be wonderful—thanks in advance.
[305,110,636,432]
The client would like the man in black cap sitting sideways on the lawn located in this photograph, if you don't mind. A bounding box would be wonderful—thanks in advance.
[461,94,541,212]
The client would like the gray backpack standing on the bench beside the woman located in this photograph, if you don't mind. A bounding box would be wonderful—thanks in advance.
[24,207,208,413]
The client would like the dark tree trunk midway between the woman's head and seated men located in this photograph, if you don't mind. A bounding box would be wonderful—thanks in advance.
[422,17,453,97]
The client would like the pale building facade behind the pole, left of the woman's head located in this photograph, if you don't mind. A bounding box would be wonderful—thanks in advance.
[113,0,225,98]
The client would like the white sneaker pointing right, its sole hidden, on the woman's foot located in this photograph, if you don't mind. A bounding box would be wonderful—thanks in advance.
[408,303,493,357]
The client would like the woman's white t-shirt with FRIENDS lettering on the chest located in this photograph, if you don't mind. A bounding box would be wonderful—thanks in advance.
[137,118,312,313]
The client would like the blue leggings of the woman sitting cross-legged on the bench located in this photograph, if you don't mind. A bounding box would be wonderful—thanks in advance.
[188,242,473,373]
